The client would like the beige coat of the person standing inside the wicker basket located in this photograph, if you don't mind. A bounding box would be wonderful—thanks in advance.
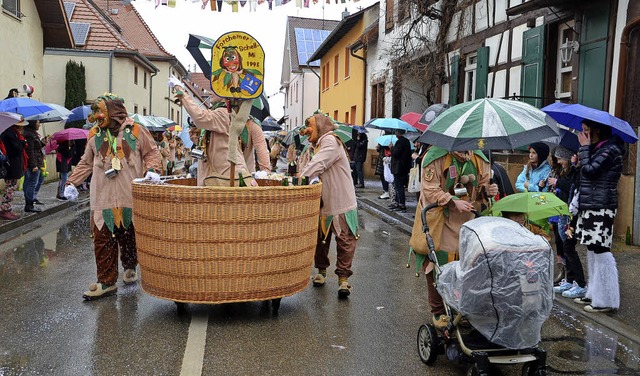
[182,94,250,185]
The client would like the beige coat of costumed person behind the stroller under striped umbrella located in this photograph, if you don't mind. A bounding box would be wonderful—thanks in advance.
[420,156,491,253]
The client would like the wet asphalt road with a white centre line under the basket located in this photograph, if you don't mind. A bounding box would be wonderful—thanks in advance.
[0,210,640,375]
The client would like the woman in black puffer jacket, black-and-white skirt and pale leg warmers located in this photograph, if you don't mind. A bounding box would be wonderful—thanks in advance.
[574,120,624,312]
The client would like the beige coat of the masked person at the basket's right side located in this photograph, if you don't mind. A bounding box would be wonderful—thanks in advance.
[300,132,357,216]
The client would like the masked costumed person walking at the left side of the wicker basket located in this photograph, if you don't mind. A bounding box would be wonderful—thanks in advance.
[65,93,160,300]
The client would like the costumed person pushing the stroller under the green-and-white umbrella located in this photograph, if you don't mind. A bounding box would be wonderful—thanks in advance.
[410,146,498,329]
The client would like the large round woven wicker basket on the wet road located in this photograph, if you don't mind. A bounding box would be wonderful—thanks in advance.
[133,179,322,303]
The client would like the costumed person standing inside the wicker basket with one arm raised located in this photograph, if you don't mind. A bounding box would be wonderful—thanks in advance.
[169,80,257,186]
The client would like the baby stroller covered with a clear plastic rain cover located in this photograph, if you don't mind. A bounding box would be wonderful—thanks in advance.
[417,204,554,376]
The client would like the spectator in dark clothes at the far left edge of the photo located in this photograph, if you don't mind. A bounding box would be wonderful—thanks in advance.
[0,119,28,221]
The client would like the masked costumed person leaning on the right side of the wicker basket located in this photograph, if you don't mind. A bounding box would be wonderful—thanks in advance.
[300,114,358,298]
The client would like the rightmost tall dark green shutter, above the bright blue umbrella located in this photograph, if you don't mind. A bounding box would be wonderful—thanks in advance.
[578,3,609,110]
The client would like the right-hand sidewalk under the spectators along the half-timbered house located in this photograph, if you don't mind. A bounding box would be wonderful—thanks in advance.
[356,179,640,343]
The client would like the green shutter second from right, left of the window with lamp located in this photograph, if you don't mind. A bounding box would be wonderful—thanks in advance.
[520,25,544,108]
